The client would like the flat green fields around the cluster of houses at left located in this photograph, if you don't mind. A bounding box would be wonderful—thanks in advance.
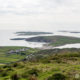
[0,47,36,64]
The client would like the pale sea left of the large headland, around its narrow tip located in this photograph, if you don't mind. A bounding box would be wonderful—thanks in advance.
[0,30,52,48]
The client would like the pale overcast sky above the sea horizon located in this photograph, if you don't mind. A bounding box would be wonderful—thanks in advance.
[0,0,80,31]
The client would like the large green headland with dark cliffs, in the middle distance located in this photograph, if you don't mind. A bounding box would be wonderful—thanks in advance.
[26,36,80,46]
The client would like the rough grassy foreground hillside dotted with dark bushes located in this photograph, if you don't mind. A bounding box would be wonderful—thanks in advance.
[0,49,80,80]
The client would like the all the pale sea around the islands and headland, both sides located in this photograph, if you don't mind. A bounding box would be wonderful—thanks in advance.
[0,30,80,48]
